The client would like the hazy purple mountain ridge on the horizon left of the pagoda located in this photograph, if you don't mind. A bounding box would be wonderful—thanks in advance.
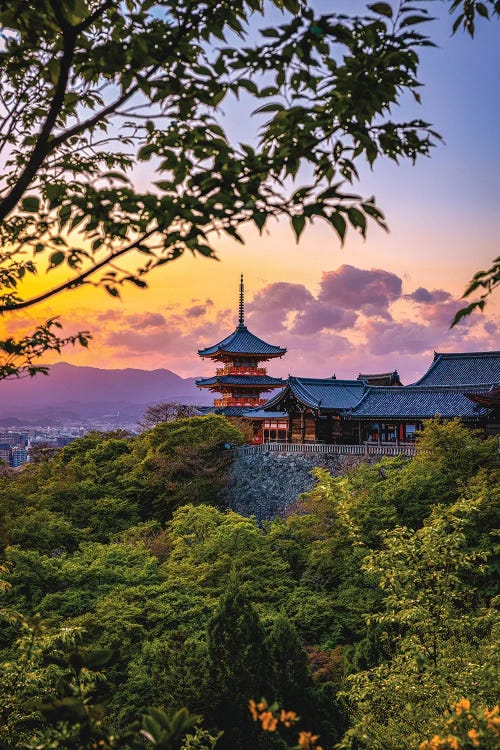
[0,362,212,421]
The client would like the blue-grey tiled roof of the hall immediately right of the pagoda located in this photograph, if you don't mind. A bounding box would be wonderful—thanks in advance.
[264,375,366,411]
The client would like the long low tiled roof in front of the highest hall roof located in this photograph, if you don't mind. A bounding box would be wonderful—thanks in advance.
[349,386,491,420]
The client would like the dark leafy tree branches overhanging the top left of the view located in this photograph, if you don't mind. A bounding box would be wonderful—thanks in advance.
[0,0,500,377]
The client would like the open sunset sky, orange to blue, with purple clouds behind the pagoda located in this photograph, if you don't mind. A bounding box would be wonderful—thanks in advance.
[3,0,500,383]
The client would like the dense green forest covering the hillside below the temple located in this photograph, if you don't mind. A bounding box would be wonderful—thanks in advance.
[0,416,500,750]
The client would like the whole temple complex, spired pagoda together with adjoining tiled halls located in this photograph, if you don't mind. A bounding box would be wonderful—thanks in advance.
[196,276,500,445]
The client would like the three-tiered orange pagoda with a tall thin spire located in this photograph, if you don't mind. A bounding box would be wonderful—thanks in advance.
[196,274,286,416]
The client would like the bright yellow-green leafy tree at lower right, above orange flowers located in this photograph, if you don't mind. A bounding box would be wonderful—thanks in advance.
[341,500,499,750]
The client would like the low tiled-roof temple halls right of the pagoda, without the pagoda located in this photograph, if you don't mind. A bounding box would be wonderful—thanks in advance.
[263,351,500,445]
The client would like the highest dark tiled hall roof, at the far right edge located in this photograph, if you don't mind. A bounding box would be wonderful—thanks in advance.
[412,351,500,386]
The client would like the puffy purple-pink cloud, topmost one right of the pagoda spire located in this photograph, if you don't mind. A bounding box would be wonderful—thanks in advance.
[318,265,403,318]
